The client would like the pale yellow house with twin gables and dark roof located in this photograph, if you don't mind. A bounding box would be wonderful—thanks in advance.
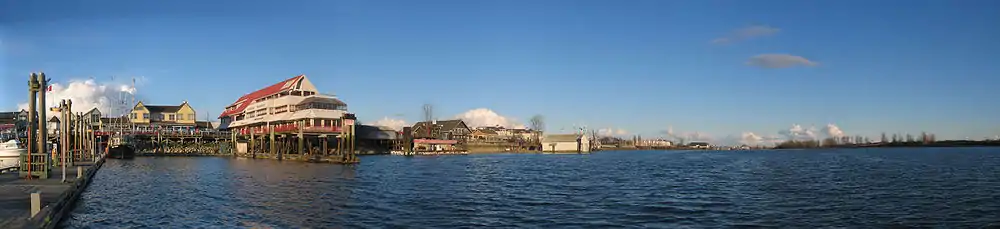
[129,101,197,127]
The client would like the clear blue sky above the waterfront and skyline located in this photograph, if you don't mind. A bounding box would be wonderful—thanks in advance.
[0,0,1000,143]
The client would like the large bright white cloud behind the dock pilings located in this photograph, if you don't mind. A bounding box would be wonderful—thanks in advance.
[17,79,138,117]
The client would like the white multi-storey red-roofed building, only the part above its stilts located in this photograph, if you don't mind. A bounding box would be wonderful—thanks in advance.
[219,75,353,134]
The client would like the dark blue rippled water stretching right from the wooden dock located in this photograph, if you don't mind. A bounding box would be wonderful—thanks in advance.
[62,148,1000,228]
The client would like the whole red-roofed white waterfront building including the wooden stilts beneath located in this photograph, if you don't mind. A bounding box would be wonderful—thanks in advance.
[219,75,358,163]
